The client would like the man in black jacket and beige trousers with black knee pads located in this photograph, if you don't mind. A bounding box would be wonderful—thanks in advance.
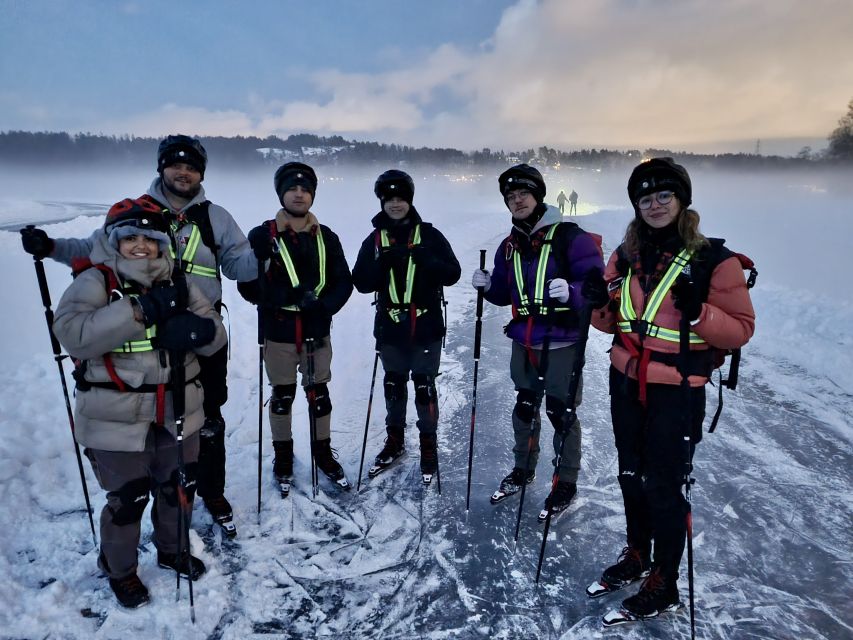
[238,162,352,495]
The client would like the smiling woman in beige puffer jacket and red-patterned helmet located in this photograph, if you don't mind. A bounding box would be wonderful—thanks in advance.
[53,196,226,608]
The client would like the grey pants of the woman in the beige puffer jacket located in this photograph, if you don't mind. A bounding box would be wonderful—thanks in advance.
[86,427,199,579]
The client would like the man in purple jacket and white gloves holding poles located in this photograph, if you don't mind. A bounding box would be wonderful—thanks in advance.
[471,164,604,515]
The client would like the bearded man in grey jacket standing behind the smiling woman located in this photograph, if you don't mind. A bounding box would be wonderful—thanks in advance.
[21,135,257,536]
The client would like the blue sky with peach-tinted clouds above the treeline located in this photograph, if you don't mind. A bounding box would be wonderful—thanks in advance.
[0,0,853,154]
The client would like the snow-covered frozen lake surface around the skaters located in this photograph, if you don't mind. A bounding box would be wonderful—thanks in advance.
[0,167,853,640]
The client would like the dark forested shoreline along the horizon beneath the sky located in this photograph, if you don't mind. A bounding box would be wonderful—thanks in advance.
[0,100,853,170]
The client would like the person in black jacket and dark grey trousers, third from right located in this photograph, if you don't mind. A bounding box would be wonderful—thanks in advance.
[353,169,461,482]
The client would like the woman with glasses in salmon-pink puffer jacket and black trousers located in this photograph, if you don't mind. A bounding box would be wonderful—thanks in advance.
[583,158,755,619]
